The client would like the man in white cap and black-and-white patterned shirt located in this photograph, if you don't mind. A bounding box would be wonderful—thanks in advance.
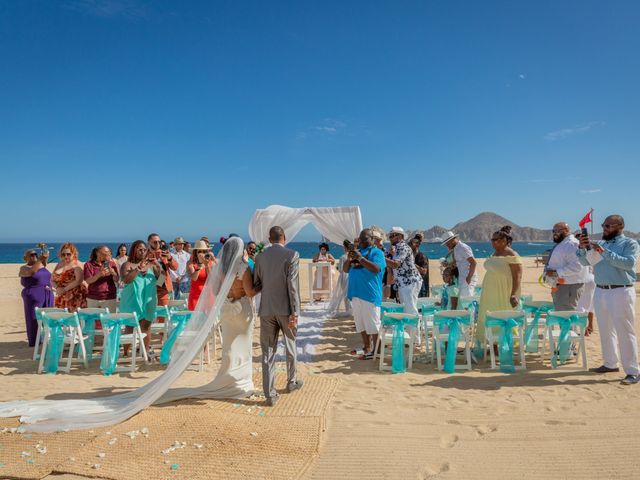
[386,227,422,315]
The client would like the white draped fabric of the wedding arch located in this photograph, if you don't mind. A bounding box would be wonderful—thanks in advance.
[249,205,362,312]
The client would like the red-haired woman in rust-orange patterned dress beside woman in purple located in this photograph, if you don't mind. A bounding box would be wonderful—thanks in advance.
[51,242,87,312]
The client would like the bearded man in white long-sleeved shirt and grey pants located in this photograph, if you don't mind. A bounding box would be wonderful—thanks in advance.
[545,222,589,310]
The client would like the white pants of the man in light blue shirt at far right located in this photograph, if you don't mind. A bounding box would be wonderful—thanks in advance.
[593,287,640,375]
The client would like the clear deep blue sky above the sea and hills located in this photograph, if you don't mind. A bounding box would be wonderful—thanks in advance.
[0,0,640,241]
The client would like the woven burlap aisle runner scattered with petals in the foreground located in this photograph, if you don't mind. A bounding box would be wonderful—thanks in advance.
[0,371,338,480]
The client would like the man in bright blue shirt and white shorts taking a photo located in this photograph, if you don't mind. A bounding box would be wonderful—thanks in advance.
[342,228,385,359]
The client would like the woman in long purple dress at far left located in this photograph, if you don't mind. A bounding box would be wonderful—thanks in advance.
[19,250,53,347]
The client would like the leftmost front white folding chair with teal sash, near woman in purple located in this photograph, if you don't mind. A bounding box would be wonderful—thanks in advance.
[38,312,89,373]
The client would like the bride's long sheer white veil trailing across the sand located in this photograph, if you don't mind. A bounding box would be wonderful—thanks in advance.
[0,237,244,432]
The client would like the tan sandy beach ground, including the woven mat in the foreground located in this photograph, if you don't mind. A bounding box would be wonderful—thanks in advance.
[0,258,640,479]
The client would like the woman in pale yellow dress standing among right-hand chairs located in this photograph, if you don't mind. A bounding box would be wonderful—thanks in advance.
[474,226,522,357]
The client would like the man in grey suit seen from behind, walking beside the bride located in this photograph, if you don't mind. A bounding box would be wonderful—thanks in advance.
[253,227,303,407]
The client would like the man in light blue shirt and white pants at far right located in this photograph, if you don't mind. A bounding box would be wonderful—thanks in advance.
[577,215,640,385]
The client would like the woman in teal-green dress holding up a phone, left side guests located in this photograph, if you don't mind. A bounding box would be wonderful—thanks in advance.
[120,240,162,351]
